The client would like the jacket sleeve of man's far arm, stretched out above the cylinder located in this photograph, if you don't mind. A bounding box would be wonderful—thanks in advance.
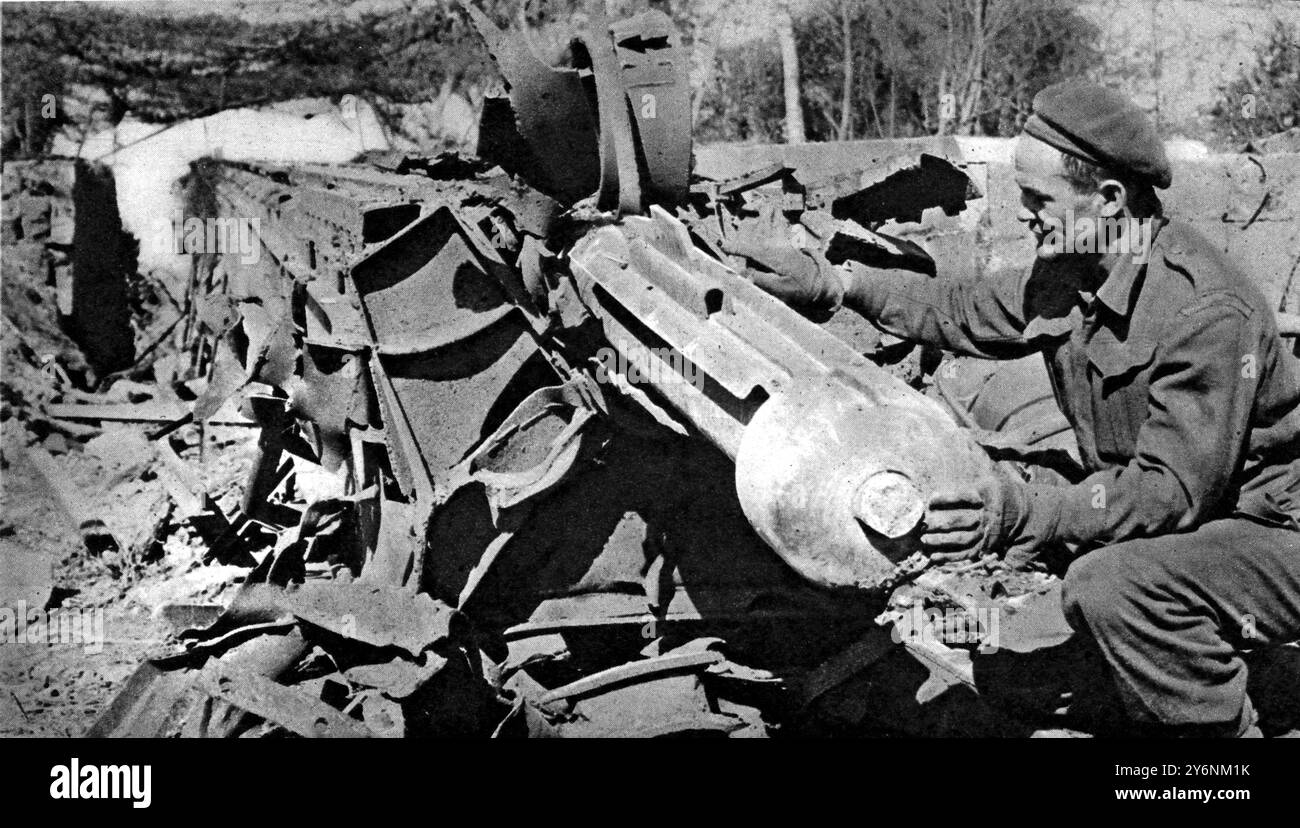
[844,263,1039,359]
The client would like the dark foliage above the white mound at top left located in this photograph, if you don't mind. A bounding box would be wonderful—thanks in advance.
[3,3,506,155]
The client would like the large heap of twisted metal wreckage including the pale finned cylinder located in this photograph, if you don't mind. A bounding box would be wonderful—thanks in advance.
[91,0,1081,736]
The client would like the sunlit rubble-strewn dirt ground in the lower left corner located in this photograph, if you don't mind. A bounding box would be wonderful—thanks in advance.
[0,429,256,736]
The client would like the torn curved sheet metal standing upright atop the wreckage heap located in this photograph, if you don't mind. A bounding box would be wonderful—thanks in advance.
[465,3,692,214]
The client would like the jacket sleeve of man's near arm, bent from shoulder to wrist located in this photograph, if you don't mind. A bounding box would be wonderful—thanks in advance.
[1013,294,1269,549]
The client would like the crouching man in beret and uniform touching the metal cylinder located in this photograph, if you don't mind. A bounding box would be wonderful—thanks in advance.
[738,81,1300,736]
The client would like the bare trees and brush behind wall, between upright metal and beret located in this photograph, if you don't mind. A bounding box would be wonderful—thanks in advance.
[698,0,1101,140]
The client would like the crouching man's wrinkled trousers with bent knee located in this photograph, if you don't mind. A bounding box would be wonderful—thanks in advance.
[1062,517,1300,736]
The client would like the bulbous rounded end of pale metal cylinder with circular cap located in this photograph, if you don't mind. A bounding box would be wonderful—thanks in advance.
[736,378,1000,589]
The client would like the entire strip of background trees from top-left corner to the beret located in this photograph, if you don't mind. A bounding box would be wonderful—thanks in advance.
[3,0,1107,157]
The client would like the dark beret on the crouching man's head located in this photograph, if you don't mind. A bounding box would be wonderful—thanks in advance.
[1024,81,1174,190]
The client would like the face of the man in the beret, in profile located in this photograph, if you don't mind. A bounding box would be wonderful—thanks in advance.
[1015,134,1100,259]
